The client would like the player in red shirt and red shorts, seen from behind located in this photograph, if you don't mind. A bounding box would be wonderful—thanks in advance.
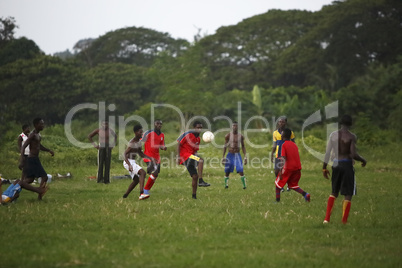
[275,128,310,202]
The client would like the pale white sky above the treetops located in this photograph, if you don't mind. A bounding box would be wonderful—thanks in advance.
[0,0,332,54]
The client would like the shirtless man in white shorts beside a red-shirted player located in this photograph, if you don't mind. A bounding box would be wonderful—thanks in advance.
[123,125,155,200]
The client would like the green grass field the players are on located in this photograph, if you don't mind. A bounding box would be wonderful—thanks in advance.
[0,126,402,267]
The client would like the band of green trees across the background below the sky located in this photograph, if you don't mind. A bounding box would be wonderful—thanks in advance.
[0,0,402,137]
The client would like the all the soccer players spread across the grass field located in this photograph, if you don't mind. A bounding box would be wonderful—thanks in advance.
[0,115,367,223]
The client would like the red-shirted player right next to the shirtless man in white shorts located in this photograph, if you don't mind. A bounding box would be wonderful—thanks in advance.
[141,119,167,199]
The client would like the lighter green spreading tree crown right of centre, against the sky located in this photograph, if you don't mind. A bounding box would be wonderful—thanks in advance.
[196,10,314,90]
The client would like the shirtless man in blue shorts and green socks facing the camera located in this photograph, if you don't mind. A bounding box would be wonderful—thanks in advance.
[222,121,247,189]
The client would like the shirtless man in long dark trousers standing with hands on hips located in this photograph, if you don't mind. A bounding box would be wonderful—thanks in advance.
[88,121,117,184]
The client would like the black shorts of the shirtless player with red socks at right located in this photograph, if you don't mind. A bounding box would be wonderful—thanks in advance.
[332,161,356,195]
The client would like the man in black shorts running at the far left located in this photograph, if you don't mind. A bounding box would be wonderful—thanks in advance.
[19,118,54,200]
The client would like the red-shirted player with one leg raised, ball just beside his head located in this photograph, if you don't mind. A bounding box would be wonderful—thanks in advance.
[177,121,210,199]
